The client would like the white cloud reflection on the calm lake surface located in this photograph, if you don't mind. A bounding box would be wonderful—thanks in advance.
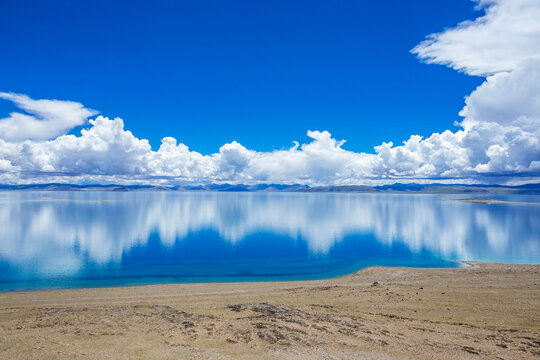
[0,192,540,273]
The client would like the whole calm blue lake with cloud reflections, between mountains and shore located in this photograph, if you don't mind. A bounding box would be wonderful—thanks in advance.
[0,191,540,291]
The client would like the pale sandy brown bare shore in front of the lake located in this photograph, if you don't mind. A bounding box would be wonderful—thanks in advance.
[0,263,540,359]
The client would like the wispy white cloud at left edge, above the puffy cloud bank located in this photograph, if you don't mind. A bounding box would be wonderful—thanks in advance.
[0,92,96,141]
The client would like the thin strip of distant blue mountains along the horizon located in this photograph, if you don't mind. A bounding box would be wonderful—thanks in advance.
[0,183,540,194]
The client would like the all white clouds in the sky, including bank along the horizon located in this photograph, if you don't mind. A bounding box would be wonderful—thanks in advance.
[0,0,540,185]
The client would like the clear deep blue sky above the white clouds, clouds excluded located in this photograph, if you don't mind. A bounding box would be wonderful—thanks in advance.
[0,0,483,154]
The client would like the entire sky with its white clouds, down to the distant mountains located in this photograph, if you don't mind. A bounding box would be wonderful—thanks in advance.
[0,0,540,186]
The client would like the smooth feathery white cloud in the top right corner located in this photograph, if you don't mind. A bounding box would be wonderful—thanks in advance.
[412,0,540,75]
